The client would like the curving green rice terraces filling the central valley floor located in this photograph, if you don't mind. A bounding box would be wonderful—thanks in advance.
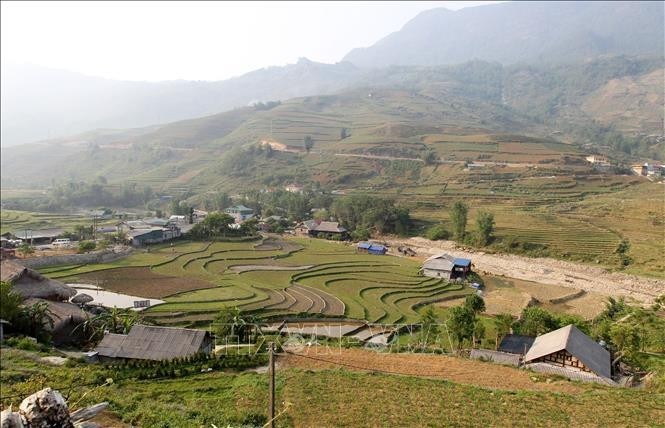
[42,238,471,326]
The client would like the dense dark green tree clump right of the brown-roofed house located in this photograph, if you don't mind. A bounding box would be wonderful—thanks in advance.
[331,195,411,239]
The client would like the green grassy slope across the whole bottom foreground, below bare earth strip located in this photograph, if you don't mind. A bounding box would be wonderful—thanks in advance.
[0,349,665,427]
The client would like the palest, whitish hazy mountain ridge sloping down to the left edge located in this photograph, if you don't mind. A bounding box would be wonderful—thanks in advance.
[2,58,360,147]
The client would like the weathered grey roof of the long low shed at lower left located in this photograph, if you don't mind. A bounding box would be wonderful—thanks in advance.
[95,325,213,361]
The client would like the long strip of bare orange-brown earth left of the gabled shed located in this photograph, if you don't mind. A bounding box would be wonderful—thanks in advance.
[278,346,581,393]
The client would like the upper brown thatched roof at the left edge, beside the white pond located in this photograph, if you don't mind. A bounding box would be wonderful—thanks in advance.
[0,260,76,302]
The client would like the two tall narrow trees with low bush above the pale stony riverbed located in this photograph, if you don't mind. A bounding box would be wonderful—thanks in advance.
[425,201,495,246]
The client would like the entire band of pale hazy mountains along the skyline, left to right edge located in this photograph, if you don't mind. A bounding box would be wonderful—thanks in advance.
[1,2,664,147]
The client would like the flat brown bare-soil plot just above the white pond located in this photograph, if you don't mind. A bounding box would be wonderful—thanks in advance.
[77,267,214,299]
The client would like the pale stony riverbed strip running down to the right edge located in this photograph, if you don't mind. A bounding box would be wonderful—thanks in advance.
[382,237,665,303]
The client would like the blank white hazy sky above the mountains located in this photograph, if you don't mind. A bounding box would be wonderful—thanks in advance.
[1,1,504,80]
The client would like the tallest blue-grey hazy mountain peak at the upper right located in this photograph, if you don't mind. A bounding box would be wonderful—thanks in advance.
[344,2,665,67]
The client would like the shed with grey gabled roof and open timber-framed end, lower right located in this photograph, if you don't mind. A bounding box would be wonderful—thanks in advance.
[524,324,612,378]
